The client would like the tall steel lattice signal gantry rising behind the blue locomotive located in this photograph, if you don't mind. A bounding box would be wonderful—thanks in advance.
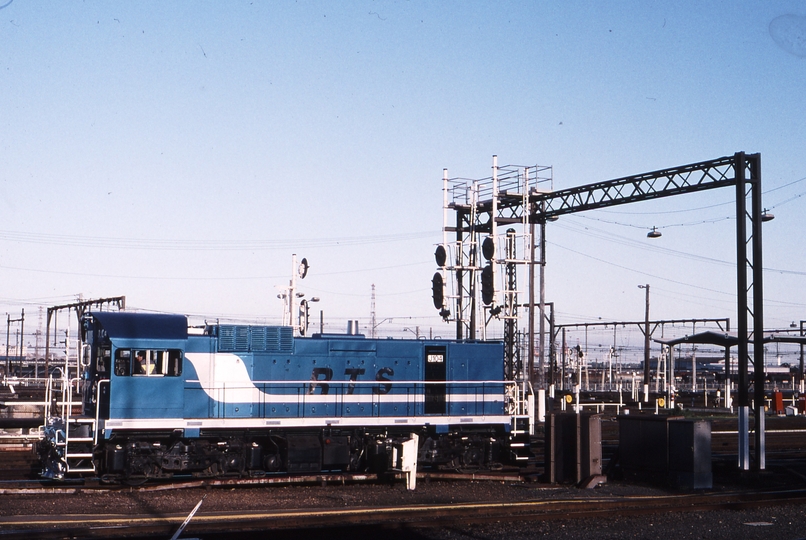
[435,152,766,470]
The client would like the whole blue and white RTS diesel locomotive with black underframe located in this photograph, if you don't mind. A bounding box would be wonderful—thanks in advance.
[39,312,531,483]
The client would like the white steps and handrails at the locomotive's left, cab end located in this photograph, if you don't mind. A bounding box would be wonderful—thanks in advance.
[45,379,98,474]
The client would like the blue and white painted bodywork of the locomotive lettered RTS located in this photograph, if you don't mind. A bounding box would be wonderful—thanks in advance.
[87,312,513,438]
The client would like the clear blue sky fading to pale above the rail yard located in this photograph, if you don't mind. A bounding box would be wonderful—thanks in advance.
[0,0,806,348]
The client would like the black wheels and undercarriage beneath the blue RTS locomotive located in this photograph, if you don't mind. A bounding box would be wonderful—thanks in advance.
[95,430,516,482]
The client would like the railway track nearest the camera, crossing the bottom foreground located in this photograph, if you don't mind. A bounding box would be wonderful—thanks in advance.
[2,489,806,539]
